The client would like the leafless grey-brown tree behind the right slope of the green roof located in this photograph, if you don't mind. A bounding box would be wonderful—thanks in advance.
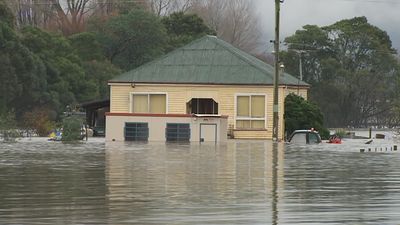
[192,0,261,52]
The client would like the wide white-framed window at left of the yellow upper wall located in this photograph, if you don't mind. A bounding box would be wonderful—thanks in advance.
[131,93,167,114]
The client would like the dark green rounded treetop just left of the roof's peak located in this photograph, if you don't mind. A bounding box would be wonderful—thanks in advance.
[161,12,216,52]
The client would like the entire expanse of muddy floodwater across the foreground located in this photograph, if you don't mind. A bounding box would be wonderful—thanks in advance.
[0,139,400,225]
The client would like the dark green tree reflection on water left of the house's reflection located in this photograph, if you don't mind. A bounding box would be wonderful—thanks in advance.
[0,141,108,224]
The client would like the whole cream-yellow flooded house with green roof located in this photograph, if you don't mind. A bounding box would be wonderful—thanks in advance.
[106,36,309,142]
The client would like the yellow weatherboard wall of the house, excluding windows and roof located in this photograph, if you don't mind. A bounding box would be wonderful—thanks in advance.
[110,83,307,139]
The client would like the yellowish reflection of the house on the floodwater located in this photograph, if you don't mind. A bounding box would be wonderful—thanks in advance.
[106,142,284,224]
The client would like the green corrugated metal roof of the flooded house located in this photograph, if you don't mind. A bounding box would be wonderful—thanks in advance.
[109,36,309,86]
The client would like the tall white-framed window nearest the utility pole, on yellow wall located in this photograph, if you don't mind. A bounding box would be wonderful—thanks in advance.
[236,95,265,129]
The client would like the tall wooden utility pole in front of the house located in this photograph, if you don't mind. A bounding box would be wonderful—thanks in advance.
[272,0,283,141]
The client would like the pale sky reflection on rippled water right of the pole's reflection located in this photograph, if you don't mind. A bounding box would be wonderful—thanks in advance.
[283,143,400,224]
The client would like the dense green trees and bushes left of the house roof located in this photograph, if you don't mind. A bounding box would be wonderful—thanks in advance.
[0,0,214,134]
